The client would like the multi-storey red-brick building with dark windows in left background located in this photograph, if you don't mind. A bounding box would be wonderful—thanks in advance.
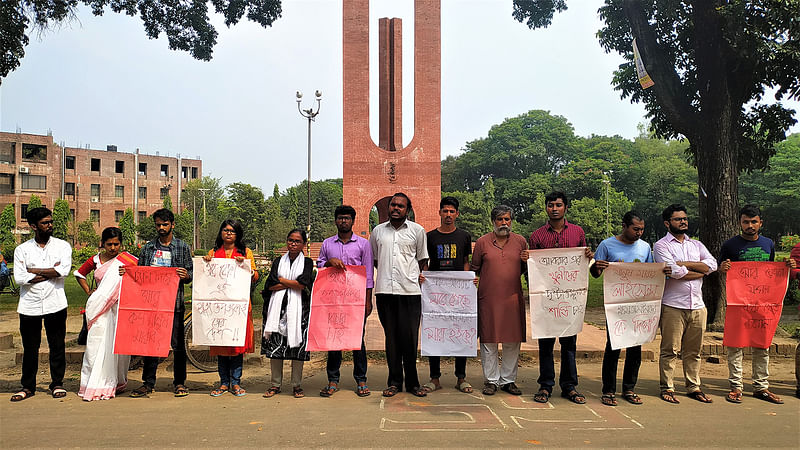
[0,132,202,239]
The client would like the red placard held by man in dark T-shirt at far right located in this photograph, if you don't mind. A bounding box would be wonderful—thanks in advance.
[722,261,789,348]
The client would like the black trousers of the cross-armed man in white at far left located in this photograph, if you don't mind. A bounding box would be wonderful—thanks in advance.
[19,308,67,392]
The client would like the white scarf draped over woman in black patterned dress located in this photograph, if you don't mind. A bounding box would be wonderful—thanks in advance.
[264,252,306,348]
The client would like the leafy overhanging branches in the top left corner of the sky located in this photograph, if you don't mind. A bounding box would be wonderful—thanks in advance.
[0,0,281,79]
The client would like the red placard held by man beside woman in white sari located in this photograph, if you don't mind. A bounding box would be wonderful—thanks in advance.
[114,266,178,357]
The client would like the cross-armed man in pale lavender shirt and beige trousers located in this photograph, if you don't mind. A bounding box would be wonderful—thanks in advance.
[653,204,717,403]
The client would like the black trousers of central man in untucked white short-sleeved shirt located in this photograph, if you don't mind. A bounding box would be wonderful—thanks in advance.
[375,294,422,392]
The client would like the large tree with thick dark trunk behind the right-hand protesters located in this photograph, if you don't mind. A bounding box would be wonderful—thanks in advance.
[514,0,800,328]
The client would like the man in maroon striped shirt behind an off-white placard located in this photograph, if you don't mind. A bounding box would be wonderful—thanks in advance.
[529,192,594,404]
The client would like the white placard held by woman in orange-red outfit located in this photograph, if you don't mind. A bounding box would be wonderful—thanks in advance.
[192,258,252,347]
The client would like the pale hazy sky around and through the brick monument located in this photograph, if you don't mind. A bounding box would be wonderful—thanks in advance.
[0,0,800,195]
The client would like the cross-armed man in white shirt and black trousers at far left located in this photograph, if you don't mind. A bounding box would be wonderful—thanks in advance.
[11,208,72,402]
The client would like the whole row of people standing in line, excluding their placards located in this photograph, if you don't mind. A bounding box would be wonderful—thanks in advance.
[11,192,800,406]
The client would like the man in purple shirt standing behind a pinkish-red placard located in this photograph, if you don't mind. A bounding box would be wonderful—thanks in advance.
[317,205,374,397]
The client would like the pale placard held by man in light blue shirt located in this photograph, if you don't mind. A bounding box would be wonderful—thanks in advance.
[603,262,666,350]
